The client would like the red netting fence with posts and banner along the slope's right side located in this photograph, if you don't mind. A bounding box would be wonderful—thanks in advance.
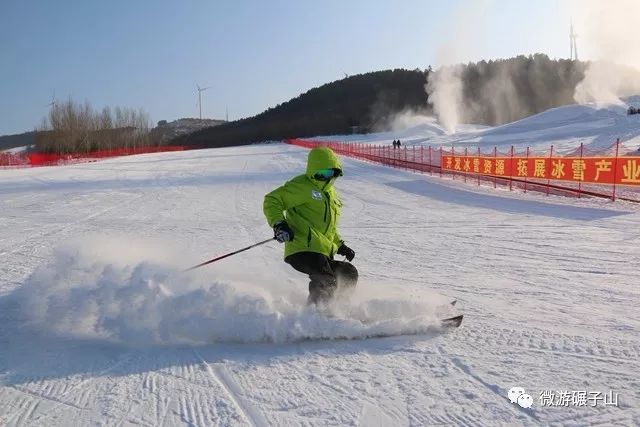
[286,139,640,202]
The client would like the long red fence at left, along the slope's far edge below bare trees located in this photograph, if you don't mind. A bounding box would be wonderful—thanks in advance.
[0,146,198,167]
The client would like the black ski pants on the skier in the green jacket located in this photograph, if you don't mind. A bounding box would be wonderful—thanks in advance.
[284,252,358,304]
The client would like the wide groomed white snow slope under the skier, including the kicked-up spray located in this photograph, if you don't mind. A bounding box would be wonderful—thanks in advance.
[0,144,640,426]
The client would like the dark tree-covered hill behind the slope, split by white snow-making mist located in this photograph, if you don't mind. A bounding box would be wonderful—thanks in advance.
[174,54,586,147]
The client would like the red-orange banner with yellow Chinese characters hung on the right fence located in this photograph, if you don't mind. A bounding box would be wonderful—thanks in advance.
[442,155,640,185]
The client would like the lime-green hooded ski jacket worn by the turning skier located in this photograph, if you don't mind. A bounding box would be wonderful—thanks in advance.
[263,147,342,258]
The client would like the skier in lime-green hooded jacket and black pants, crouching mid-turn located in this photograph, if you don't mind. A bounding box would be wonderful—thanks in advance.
[264,147,358,304]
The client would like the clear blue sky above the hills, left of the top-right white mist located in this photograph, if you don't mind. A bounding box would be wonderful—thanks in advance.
[0,0,570,135]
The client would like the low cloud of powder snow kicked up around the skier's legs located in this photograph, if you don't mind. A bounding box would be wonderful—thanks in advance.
[11,239,452,346]
